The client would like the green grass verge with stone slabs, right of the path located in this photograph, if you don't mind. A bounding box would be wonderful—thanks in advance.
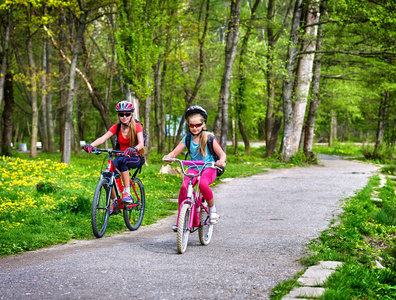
[271,175,396,300]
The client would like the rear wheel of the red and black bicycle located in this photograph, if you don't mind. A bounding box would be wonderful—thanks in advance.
[123,177,146,231]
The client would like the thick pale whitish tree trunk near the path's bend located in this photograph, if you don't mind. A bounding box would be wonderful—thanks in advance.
[293,0,319,152]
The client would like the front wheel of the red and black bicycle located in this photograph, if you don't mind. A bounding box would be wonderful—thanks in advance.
[91,178,111,238]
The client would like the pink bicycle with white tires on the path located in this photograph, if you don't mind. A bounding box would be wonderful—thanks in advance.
[167,158,217,254]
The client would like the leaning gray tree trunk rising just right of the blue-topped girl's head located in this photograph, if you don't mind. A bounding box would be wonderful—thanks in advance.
[214,0,241,151]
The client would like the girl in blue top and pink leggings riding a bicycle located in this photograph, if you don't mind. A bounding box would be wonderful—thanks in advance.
[163,106,226,226]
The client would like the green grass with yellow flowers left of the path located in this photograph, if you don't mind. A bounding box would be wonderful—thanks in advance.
[0,148,290,256]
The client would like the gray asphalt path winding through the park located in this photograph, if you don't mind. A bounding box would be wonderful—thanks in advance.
[0,156,378,299]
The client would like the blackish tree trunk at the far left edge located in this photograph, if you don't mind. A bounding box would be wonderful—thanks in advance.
[0,72,16,156]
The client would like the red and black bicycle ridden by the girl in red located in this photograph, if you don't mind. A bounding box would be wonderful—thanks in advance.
[91,149,146,238]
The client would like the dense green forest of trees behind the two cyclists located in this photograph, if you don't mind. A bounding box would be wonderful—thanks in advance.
[0,0,396,164]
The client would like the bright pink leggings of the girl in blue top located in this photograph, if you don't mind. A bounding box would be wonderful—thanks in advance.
[179,168,217,205]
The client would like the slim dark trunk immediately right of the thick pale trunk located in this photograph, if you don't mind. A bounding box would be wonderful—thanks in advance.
[304,1,326,156]
